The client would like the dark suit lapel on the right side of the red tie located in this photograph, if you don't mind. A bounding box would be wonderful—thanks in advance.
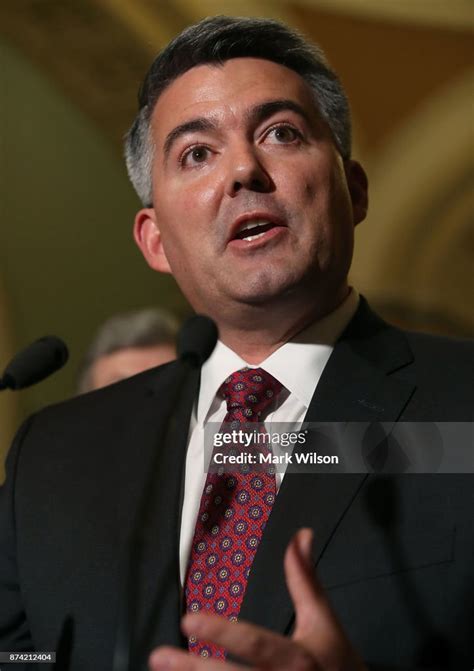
[240,299,414,633]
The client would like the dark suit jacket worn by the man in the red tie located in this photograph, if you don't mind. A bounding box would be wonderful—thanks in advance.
[0,300,474,671]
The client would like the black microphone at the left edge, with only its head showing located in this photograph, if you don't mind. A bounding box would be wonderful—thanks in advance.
[0,336,69,390]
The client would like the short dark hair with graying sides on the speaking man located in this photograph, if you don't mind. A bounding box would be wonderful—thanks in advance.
[125,16,351,207]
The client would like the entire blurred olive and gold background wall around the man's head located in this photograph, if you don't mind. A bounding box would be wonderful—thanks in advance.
[0,0,474,477]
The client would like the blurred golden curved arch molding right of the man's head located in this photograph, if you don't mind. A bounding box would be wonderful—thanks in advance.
[352,71,474,335]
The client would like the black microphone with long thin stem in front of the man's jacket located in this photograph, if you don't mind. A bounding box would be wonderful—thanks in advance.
[112,315,218,671]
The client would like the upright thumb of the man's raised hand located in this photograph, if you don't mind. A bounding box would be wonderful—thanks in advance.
[285,529,339,640]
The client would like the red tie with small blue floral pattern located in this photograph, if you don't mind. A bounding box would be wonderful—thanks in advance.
[185,368,282,659]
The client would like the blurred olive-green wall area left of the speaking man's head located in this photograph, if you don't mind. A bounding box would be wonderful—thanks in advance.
[0,42,189,472]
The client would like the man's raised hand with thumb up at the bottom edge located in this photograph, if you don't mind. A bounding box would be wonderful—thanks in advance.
[149,529,366,671]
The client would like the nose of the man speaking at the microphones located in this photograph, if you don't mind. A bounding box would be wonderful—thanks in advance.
[227,145,273,198]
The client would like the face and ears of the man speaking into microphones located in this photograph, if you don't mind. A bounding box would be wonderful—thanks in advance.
[135,58,366,316]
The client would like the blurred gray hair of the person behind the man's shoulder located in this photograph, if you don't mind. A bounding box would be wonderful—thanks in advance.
[77,308,179,394]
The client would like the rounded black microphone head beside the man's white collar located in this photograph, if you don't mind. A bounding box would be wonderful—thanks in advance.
[177,315,219,368]
